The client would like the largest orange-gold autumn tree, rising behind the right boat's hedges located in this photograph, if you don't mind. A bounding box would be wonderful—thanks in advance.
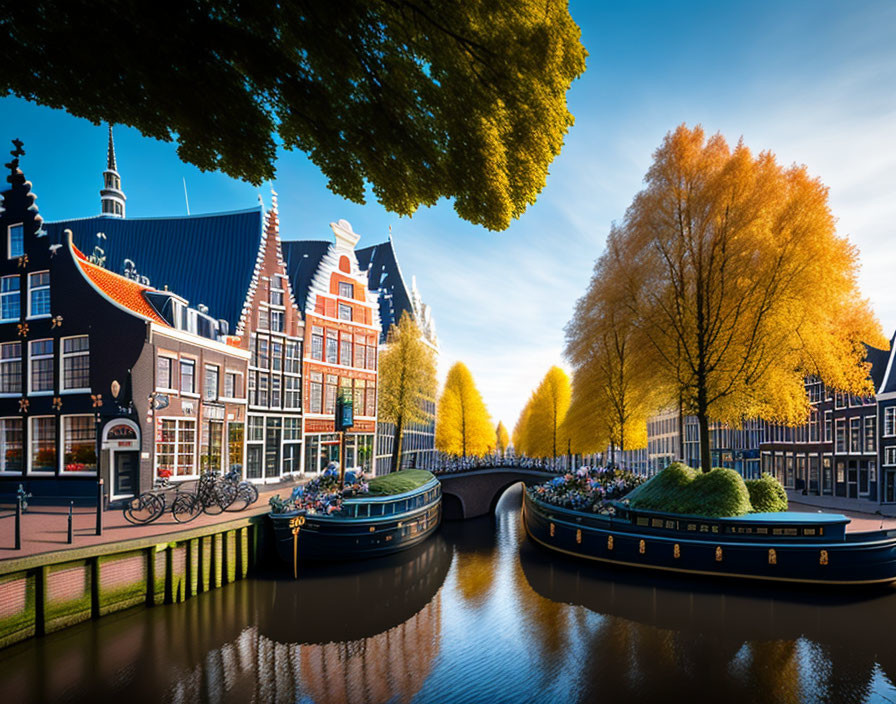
[609,125,887,471]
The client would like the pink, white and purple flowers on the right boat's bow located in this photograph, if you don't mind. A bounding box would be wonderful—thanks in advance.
[526,467,644,513]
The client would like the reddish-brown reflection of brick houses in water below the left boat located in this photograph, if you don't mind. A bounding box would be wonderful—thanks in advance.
[167,594,442,704]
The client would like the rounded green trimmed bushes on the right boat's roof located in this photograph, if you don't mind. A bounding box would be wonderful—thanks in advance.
[626,462,787,518]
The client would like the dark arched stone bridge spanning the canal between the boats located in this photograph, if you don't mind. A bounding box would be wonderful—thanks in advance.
[436,467,558,520]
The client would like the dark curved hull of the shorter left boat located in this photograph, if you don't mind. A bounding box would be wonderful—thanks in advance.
[269,497,442,564]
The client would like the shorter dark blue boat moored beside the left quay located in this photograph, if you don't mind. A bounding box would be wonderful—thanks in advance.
[268,472,442,564]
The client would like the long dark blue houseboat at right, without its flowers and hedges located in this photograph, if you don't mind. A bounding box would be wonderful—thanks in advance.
[523,493,896,584]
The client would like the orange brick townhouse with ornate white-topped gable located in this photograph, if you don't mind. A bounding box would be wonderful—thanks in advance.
[283,220,381,472]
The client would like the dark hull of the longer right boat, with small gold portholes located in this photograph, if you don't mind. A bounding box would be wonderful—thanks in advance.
[522,494,896,585]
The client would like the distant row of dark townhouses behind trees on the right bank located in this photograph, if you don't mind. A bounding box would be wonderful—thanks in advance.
[636,336,896,504]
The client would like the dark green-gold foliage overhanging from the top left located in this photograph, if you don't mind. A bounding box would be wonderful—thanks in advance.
[0,0,586,229]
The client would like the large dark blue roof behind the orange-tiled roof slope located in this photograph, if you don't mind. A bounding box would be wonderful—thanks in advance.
[44,206,263,333]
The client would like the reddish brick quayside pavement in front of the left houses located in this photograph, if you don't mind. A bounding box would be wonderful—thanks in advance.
[0,479,306,564]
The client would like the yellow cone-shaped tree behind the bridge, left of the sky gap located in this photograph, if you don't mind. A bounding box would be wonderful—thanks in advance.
[436,362,495,457]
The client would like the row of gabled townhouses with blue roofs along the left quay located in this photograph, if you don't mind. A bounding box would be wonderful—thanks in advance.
[0,132,438,500]
